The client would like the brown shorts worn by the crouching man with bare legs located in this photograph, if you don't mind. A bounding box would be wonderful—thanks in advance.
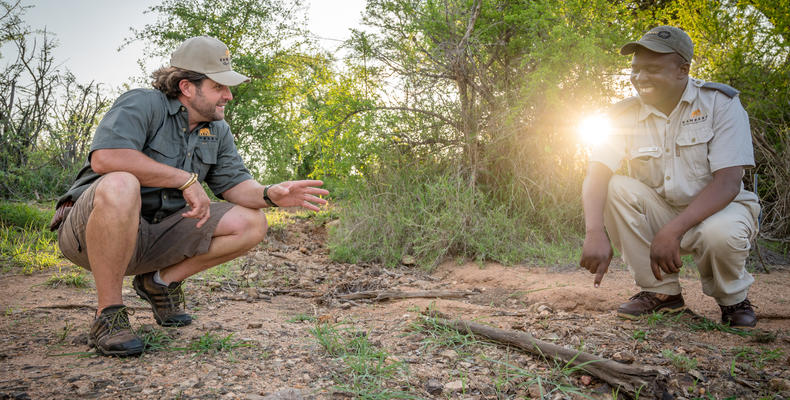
[58,178,234,275]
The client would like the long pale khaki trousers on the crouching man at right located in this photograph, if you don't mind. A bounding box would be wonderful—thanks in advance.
[604,175,760,306]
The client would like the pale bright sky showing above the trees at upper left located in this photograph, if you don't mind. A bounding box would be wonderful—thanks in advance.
[17,0,365,87]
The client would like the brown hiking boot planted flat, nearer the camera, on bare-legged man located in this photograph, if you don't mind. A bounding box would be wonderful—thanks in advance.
[88,304,145,357]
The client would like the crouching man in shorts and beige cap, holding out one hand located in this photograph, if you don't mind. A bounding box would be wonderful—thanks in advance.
[51,36,328,356]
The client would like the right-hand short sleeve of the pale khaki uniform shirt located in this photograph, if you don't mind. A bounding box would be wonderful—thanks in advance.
[708,93,754,172]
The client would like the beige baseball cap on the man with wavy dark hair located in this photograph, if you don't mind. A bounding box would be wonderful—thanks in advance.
[170,36,250,86]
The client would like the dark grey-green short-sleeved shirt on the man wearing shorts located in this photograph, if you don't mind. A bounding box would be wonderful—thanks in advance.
[58,89,252,223]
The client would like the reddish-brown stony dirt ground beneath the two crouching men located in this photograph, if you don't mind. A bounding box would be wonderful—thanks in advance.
[0,216,790,400]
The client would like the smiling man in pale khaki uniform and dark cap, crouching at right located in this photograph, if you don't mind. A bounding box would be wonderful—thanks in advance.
[580,26,760,327]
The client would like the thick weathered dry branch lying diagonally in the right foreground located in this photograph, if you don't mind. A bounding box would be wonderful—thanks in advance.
[431,312,670,399]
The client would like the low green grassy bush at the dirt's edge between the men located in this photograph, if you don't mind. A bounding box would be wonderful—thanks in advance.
[329,166,580,268]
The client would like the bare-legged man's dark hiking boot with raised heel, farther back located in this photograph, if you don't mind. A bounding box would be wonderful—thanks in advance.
[132,272,192,326]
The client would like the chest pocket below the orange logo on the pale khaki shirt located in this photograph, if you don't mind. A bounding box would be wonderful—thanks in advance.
[675,125,713,180]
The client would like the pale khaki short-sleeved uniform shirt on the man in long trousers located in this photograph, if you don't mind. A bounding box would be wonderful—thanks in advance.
[590,78,757,207]
